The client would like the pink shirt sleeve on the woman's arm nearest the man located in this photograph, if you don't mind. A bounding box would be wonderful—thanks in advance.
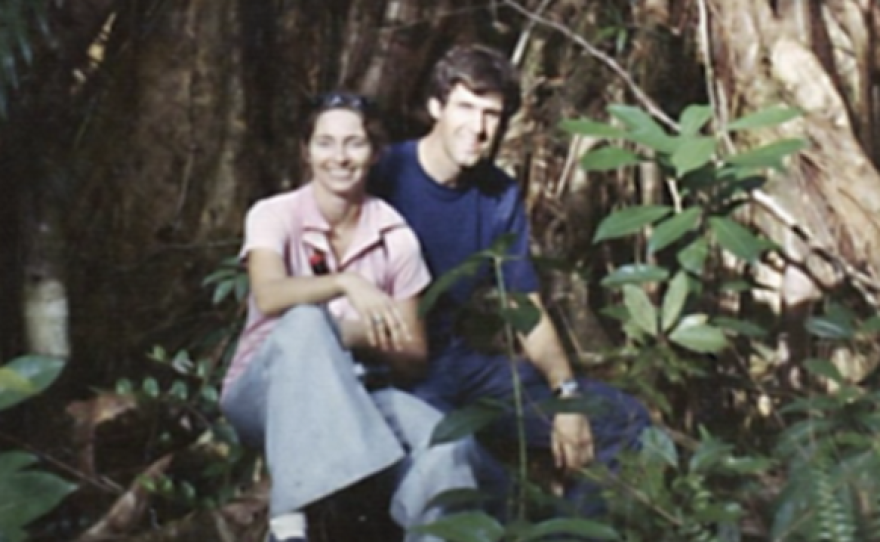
[385,228,431,299]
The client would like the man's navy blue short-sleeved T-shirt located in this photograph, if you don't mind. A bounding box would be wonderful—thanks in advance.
[370,140,538,352]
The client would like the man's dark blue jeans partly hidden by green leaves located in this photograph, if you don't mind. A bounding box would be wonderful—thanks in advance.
[411,342,651,516]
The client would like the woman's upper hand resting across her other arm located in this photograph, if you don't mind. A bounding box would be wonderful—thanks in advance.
[338,273,412,350]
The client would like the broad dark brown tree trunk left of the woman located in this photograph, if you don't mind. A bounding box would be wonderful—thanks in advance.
[68,0,248,382]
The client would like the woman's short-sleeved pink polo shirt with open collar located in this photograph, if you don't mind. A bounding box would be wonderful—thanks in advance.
[223,184,430,390]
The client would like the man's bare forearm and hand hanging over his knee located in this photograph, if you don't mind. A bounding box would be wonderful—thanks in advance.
[522,293,593,471]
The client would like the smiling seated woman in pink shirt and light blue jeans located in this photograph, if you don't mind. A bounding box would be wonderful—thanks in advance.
[221,93,474,542]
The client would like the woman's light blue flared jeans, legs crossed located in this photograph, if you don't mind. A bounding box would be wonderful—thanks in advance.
[221,306,475,541]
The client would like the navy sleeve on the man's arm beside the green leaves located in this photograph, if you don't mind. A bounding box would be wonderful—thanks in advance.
[497,188,540,294]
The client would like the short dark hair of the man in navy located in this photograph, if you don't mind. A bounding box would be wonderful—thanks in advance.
[429,44,522,117]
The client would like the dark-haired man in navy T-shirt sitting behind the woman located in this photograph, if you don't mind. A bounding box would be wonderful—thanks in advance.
[372,45,649,513]
